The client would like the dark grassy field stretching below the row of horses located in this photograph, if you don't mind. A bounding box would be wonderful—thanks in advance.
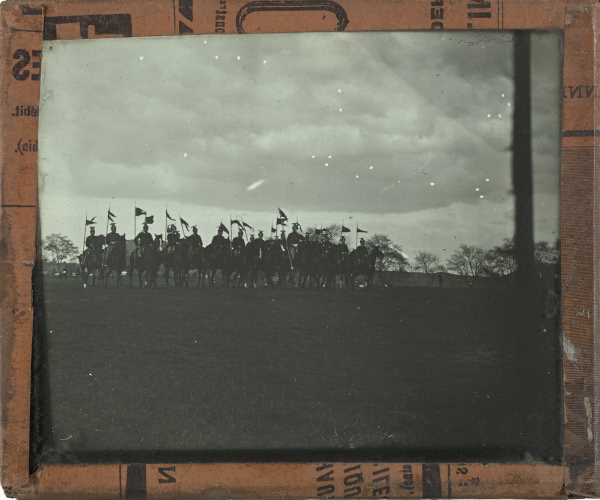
[36,280,562,462]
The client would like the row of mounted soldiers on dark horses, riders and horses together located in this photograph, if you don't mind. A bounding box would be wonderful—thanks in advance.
[80,223,383,288]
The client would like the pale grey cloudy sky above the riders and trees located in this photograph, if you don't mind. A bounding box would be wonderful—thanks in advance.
[39,31,561,257]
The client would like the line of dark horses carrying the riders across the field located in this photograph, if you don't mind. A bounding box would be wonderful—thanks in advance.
[80,235,383,289]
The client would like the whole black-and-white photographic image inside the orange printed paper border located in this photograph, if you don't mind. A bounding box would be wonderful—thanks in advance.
[34,30,563,464]
